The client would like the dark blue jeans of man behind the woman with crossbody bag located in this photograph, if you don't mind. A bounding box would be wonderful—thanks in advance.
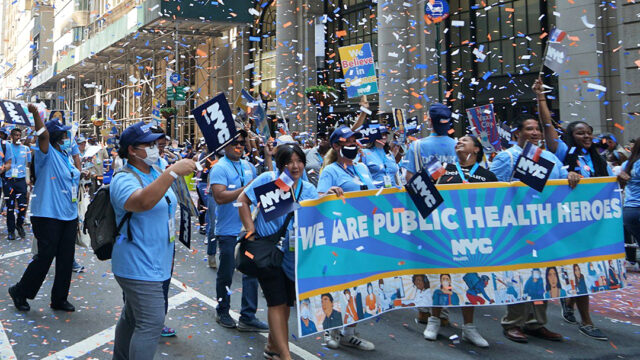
[216,235,258,322]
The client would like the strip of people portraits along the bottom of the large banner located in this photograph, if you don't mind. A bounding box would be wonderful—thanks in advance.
[298,259,626,336]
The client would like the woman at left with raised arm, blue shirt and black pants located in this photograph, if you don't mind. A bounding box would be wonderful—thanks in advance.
[9,105,80,311]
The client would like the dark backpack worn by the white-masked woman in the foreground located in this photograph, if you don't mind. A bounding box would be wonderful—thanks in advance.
[82,166,144,261]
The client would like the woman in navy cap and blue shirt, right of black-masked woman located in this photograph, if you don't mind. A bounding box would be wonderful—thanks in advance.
[362,126,400,188]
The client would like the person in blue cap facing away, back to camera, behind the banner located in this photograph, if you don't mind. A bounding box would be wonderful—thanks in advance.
[400,103,458,182]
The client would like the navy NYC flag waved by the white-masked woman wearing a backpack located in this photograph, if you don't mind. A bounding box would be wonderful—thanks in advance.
[191,93,237,152]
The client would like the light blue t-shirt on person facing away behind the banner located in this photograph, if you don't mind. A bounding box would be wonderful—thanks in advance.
[400,134,458,174]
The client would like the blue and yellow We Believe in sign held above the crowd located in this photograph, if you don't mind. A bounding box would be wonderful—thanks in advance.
[338,43,378,98]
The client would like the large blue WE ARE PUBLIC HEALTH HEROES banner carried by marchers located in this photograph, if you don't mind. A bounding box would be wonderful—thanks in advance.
[296,177,626,336]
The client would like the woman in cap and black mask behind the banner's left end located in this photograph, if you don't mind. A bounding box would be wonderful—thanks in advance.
[318,125,376,196]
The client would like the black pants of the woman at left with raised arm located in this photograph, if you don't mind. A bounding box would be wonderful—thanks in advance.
[16,216,78,304]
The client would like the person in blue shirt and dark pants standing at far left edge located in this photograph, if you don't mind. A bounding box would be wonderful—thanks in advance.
[4,128,31,240]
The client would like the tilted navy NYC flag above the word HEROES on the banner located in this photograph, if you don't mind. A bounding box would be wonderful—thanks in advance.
[513,143,553,192]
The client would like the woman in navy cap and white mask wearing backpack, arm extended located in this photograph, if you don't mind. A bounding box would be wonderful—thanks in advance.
[110,122,196,359]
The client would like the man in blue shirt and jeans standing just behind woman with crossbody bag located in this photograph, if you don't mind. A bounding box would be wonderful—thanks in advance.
[209,130,269,331]
